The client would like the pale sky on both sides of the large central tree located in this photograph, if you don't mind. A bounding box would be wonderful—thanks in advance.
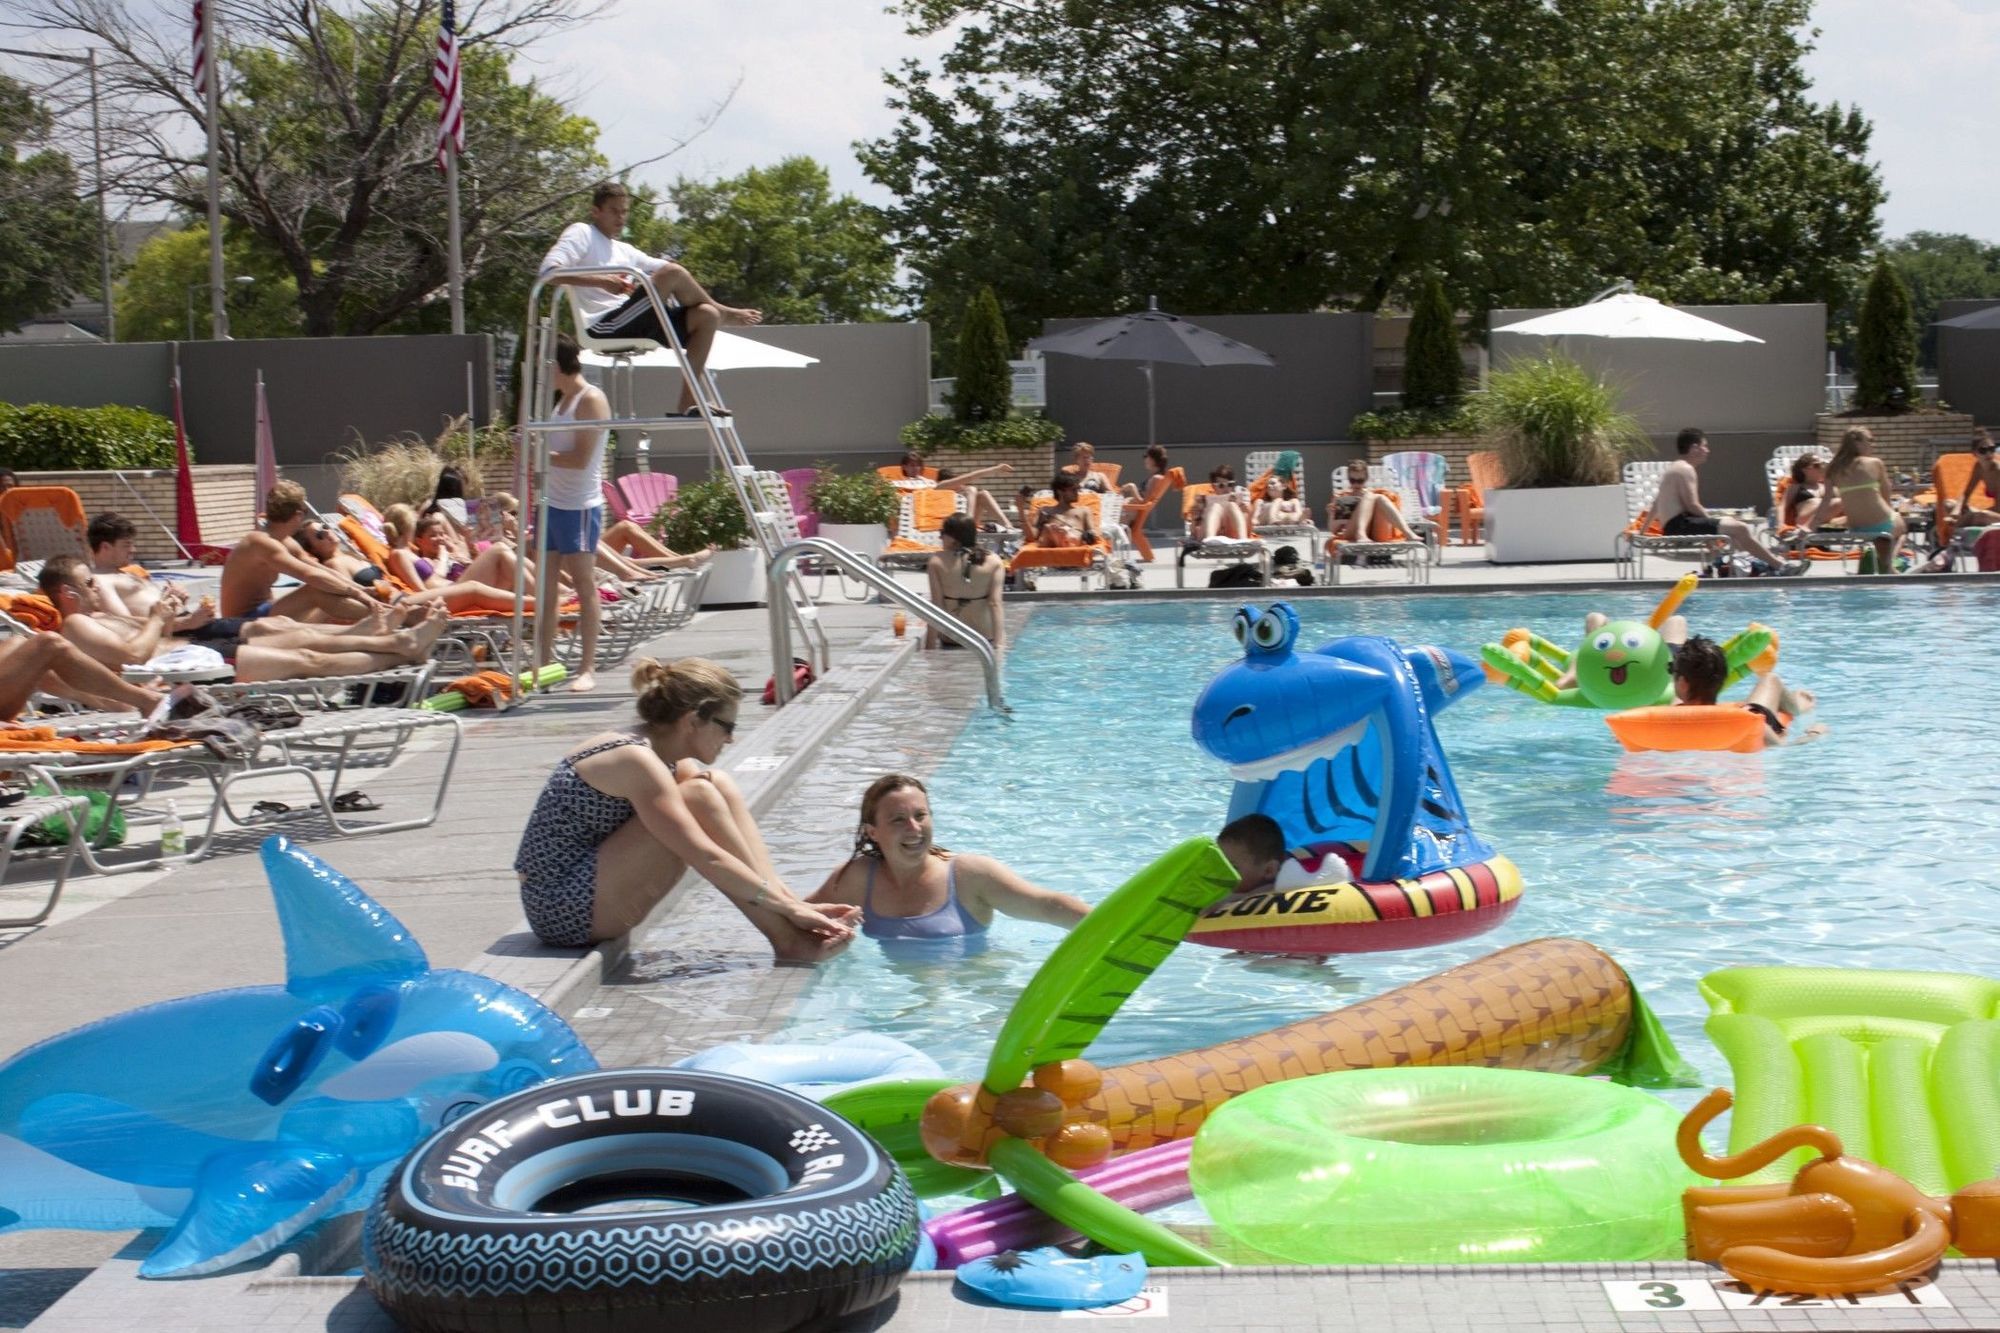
[544,0,2000,242]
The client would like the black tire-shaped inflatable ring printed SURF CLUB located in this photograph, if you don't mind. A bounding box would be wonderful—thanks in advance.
[362,1069,918,1333]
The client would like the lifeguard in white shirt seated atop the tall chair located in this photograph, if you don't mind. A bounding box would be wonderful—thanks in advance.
[542,180,764,416]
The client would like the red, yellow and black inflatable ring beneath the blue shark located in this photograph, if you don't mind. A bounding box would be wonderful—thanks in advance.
[1188,849,1520,953]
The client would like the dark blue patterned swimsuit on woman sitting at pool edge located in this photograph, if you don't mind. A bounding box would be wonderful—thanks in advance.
[514,737,646,949]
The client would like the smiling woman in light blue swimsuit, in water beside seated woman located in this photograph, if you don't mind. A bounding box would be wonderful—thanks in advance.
[808,773,1090,953]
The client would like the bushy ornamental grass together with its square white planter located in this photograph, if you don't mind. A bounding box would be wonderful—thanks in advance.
[1470,352,1648,564]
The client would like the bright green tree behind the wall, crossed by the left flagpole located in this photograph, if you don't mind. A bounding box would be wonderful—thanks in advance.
[116,224,302,342]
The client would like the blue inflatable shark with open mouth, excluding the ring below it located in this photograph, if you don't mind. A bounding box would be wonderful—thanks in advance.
[1194,602,1494,881]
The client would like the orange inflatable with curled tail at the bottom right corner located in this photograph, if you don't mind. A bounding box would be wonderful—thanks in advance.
[1676,1089,2000,1297]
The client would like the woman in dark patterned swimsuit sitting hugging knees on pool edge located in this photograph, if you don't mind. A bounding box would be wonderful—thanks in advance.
[514,656,856,948]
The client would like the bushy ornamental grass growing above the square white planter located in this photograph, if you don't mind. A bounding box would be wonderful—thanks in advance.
[1476,352,1646,488]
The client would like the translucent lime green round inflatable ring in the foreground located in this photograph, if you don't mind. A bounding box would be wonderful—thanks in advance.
[1188,1067,1696,1263]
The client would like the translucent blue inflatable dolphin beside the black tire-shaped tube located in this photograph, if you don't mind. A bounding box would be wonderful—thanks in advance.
[0,837,598,1277]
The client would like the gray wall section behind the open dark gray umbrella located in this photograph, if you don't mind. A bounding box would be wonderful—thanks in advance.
[1042,314,1374,452]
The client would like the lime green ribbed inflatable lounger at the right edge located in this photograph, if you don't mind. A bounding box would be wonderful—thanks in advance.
[1702,967,2000,1197]
